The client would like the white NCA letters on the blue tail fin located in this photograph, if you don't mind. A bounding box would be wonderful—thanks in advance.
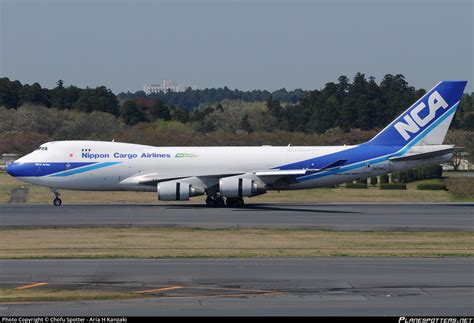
[394,91,448,140]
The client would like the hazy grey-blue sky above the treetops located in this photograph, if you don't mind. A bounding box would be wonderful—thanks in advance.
[0,0,474,93]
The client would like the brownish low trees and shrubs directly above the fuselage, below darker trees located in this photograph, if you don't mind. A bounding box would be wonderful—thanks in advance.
[0,104,382,154]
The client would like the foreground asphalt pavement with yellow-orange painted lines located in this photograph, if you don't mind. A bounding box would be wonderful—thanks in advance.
[0,258,474,316]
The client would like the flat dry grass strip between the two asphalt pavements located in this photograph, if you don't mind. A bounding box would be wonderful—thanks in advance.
[0,228,474,259]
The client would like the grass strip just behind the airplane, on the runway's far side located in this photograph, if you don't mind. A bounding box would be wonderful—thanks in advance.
[0,172,474,204]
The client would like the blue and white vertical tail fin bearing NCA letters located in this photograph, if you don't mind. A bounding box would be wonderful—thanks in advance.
[367,81,467,146]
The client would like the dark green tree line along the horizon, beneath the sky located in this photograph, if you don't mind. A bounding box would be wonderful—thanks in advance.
[0,73,474,133]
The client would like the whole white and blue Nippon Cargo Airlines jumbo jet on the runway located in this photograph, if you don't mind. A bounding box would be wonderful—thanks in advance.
[7,81,467,207]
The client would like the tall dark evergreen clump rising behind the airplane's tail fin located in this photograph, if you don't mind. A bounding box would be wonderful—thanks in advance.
[267,73,474,133]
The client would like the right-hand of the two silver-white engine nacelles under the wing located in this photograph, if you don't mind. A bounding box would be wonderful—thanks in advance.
[219,177,266,197]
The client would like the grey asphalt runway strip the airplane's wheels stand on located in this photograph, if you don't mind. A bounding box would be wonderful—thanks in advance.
[0,203,474,231]
